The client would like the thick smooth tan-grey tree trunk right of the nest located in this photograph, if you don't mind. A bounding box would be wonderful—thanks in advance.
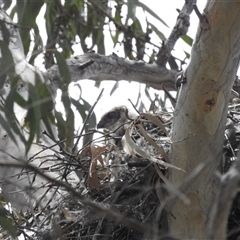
[169,0,240,239]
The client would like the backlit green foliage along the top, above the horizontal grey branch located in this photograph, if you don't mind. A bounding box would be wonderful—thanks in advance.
[5,0,192,69]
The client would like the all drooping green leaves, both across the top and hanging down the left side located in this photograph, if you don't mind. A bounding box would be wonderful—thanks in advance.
[0,0,192,154]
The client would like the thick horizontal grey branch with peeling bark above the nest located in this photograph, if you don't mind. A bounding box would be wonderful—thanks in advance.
[45,53,177,94]
